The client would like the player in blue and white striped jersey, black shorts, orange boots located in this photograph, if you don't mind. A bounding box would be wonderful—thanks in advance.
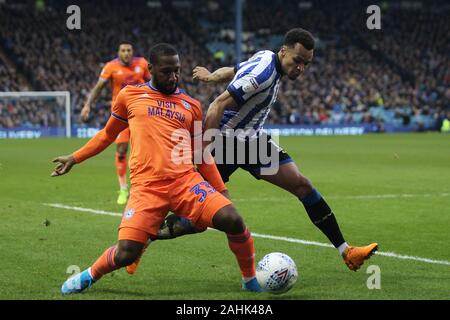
[143,28,378,271]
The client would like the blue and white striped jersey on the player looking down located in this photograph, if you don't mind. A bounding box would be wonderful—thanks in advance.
[220,50,282,138]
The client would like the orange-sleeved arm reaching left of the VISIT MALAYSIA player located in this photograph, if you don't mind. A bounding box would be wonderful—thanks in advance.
[51,116,128,177]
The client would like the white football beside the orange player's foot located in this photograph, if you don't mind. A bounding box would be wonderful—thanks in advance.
[256,252,298,294]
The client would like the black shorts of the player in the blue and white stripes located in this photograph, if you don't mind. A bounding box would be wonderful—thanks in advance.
[212,134,293,182]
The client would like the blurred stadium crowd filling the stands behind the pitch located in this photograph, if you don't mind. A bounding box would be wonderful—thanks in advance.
[0,0,450,130]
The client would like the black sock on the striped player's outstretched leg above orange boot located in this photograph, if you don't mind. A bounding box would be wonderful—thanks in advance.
[300,189,345,248]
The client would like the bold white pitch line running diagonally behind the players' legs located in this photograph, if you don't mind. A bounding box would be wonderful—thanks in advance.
[43,203,450,266]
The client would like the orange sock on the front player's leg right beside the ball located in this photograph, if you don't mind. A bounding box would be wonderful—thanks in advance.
[227,228,256,278]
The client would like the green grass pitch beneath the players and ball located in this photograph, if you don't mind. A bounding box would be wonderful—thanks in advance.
[0,134,450,300]
